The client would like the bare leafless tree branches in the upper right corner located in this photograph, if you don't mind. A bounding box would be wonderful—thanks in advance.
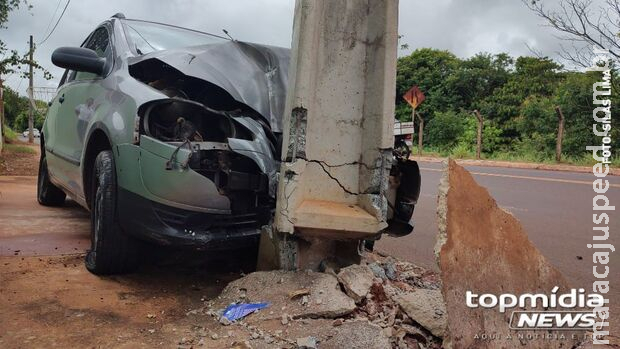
[521,0,620,67]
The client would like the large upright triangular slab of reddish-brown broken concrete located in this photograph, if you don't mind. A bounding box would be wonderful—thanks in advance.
[435,160,580,348]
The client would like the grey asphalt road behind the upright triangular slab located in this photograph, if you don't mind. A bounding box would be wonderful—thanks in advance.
[376,162,620,328]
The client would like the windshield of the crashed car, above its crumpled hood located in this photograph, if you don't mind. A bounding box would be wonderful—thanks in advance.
[122,20,228,55]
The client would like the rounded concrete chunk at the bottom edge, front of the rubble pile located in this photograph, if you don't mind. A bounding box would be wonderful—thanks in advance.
[320,321,391,349]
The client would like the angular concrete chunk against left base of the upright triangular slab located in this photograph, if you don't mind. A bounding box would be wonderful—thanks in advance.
[394,289,447,338]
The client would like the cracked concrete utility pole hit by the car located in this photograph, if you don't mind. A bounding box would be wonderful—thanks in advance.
[259,0,398,269]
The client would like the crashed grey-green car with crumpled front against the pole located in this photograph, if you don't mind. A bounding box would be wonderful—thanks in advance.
[37,14,290,274]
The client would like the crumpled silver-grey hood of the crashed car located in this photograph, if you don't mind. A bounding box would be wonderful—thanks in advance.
[129,41,290,132]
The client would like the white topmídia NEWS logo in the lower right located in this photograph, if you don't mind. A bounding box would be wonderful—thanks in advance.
[465,286,605,331]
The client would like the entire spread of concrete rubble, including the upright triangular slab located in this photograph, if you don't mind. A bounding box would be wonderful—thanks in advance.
[167,162,616,349]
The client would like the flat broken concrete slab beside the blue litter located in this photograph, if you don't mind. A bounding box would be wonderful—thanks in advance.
[213,271,355,323]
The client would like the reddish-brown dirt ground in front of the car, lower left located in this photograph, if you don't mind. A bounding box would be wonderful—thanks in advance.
[0,254,245,348]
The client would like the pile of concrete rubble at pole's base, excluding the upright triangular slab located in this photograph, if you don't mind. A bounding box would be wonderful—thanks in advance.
[179,253,444,349]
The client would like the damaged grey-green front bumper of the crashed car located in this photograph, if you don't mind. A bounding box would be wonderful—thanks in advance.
[117,108,277,245]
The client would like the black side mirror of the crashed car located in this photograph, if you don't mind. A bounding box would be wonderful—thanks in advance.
[52,47,106,75]
